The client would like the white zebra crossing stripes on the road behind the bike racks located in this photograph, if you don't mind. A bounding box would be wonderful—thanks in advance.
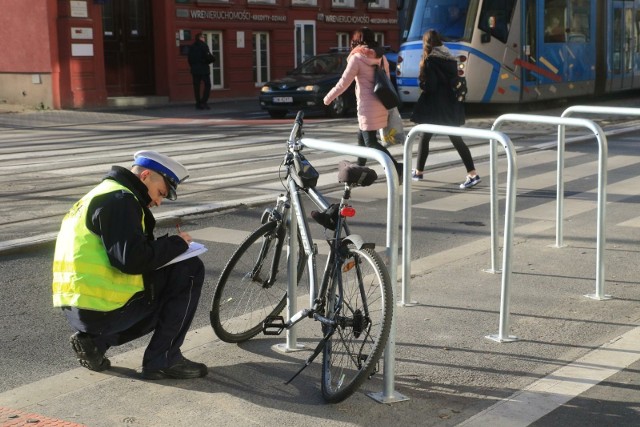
[186,150,640,255]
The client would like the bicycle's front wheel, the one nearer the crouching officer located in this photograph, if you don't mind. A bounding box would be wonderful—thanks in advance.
[209,221,305,343]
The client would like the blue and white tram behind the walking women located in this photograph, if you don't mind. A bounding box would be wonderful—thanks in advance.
[397,0,640,103]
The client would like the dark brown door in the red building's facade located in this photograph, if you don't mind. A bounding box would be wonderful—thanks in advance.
[102,0,155,96]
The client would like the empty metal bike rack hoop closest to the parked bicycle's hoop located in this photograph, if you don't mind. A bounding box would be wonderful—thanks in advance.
[401,124,517,342]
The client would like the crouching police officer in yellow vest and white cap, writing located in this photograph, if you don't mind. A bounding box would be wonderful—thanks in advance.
[53,151,207,380]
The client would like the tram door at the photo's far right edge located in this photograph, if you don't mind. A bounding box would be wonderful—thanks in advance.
[607,1,638,91]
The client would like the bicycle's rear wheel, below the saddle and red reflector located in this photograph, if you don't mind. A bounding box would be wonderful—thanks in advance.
[322,248,393,403]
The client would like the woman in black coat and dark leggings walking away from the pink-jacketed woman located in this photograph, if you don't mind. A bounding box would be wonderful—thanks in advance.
[411,30,480,189]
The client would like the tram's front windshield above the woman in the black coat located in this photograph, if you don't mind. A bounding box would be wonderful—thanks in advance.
[406,0,478,41]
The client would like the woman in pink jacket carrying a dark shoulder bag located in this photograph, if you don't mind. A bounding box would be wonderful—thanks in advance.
[324,27,402,178]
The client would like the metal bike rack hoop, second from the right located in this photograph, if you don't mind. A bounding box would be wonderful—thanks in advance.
[490,113,611,300]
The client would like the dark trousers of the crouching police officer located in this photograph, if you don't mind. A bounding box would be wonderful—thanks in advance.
[63,257,204,369]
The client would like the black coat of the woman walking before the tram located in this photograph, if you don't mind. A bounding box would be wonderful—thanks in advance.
[411,54,465,126]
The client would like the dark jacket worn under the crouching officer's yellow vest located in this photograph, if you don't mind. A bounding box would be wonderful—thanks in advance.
[86,166,189,298]
